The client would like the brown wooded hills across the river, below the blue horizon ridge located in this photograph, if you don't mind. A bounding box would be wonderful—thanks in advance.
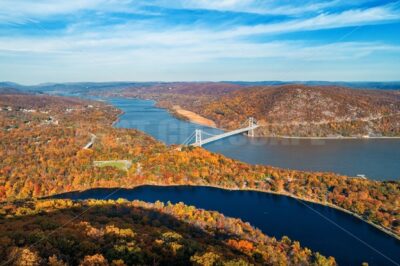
[103,83,400,137]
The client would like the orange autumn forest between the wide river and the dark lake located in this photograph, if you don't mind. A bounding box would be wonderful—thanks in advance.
[0,95,400,239]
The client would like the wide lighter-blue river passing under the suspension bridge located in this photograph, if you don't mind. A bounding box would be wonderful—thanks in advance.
[110,99,400,180]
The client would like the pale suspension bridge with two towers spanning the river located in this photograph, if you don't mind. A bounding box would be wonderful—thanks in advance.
[182,117,259,147]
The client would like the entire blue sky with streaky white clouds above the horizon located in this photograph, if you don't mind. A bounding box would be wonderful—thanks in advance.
[0,0,400,84]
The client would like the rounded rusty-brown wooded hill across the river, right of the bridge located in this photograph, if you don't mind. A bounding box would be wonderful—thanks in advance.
[197,85,400,137]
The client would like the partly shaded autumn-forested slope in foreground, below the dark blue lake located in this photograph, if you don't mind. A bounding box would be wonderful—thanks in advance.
[0,200,336,266]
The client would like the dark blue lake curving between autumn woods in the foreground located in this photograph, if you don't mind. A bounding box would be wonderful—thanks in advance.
[57,186,400,265]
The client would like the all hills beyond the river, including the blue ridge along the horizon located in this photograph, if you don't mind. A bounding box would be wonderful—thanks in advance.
[0,81,400,137]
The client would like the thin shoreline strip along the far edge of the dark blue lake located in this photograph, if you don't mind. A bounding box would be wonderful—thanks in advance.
[53,183,400,241]
